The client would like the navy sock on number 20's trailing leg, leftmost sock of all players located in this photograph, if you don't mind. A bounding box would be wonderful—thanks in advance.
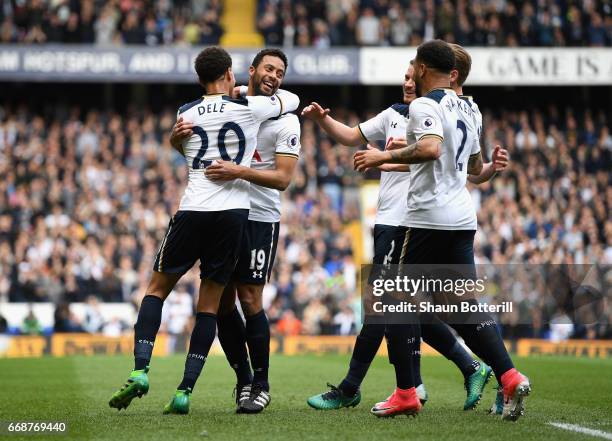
[134,295,164,370]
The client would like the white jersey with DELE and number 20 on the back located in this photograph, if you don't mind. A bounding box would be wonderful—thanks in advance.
[177,91,299,211]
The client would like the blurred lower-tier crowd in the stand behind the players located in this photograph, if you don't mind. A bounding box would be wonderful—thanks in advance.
[0,99,612,337]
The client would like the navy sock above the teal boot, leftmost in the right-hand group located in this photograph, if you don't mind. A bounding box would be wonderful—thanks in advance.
[338,324,385,397]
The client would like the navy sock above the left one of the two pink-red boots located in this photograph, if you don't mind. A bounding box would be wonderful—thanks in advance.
[385,324,421,389]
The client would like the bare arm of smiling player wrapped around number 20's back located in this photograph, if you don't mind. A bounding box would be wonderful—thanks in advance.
[206,156,298,191]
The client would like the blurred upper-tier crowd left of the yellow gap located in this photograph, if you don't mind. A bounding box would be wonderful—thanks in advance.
[0,0,223,46]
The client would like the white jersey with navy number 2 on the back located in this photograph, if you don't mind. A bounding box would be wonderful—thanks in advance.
[405,89,480,230]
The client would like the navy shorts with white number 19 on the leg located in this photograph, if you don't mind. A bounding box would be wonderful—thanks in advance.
[233,220,280,285]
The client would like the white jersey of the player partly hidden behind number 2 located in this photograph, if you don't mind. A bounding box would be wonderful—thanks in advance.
[357,104,410,226]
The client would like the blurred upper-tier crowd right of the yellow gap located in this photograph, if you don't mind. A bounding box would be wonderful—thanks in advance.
[258,0,612,48]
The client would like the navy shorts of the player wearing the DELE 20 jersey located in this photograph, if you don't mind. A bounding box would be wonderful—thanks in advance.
[153,209,249,285]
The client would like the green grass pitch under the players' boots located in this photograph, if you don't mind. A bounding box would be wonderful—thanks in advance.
[0,355,612,441]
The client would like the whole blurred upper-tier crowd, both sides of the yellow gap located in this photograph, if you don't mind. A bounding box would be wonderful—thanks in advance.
[0,0,612,48]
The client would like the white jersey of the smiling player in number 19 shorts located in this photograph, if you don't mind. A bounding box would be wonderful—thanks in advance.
[249,114,301,222]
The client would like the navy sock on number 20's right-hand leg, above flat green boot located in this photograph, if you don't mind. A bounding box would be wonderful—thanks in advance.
[177,312,217,390]
